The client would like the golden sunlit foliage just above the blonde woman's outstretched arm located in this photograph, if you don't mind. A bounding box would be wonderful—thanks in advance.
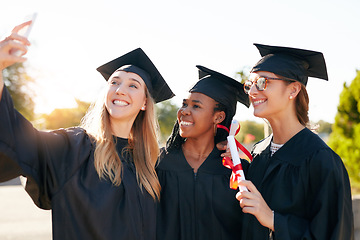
[38,99,90,130]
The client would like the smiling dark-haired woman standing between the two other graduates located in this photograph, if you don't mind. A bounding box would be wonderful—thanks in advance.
[157,66,249,240]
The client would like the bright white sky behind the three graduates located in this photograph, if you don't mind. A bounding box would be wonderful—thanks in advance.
[0,0,360,122]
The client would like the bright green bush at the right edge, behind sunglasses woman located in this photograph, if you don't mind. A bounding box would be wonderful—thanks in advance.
[328,71,360,193]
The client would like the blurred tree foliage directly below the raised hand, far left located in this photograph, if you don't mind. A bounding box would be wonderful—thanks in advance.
[3,63,35,120]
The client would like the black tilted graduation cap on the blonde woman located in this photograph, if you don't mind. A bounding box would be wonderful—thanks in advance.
[96,48,175,103]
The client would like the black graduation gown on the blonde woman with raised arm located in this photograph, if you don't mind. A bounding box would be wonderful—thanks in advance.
[0,88,156,240]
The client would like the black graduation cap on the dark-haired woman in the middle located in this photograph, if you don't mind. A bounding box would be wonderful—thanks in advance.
[189,65,250,130]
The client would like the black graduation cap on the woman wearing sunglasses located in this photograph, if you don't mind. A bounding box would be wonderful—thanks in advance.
[251,43,328,86]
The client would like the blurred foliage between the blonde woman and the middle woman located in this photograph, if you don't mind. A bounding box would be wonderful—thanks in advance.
[155,100,179,144]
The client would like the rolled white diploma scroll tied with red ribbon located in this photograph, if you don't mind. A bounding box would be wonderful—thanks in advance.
[218,120,252,191]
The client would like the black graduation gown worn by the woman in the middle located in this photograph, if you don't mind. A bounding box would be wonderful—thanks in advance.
[157,147,242,240]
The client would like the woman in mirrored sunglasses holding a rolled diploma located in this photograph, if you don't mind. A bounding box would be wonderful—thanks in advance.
[233,44,354,240]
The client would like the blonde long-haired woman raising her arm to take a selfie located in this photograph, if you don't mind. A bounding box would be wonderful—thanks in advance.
[0,23,173,240]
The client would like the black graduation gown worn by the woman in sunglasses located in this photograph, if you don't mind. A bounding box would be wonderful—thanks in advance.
[242,128,354,240]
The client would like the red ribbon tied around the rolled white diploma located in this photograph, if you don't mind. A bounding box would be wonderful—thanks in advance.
[217,124,253,189]
